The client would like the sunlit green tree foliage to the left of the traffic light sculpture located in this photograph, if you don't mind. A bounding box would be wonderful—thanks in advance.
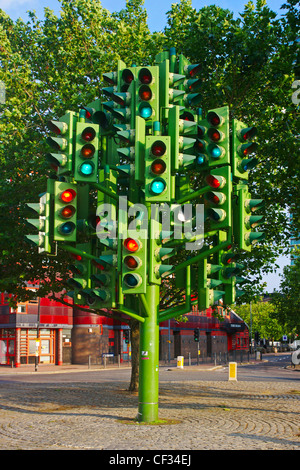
[0,0,157,298]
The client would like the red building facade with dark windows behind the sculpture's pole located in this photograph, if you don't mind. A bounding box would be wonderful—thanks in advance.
[0,286,249,367]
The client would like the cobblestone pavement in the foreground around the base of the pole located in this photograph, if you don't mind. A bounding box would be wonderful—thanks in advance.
[0,377,300,451]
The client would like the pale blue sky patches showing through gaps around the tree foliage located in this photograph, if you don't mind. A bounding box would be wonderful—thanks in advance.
[0,0,290,293]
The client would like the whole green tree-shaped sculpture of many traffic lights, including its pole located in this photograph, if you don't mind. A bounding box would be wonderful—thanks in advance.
[27,48,263,422]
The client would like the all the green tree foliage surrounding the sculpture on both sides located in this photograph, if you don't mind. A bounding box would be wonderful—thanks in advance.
[0,0,300,304]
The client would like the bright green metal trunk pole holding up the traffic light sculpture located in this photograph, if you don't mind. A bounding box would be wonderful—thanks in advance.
[138,284,159,423]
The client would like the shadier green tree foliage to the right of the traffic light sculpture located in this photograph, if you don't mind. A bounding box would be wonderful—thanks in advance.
[164,0,300,295]
